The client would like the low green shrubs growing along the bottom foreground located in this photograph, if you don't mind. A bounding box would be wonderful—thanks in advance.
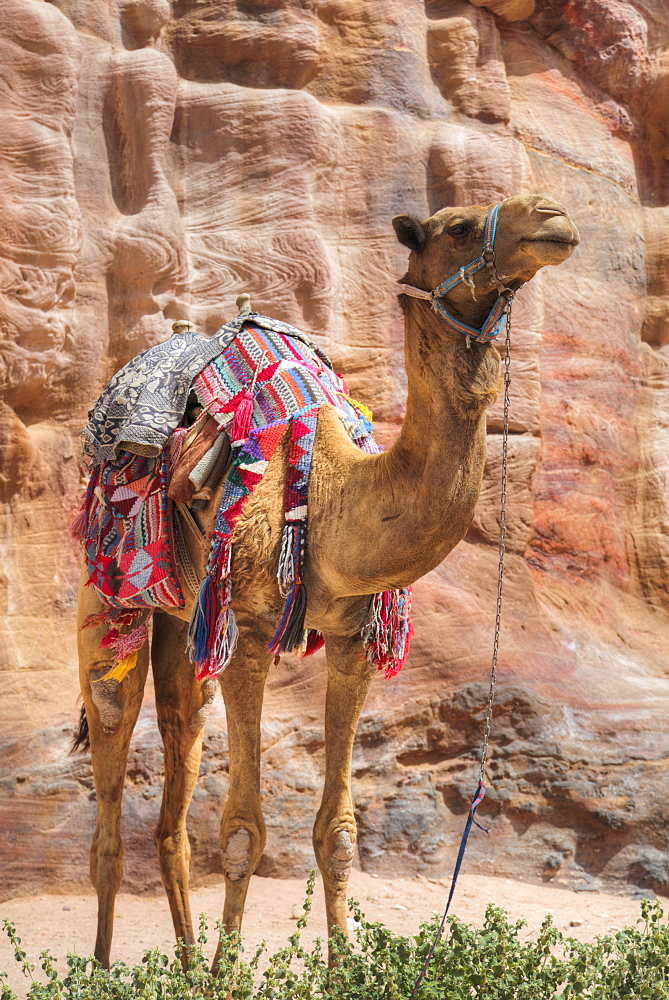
[0,874,669,1000]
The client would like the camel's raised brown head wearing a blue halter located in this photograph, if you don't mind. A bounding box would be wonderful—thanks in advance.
[393,194,579,336]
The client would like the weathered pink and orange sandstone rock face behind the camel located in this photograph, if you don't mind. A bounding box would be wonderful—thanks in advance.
[0,0,669,894]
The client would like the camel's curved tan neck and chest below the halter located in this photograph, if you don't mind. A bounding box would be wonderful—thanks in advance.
[307,292,500,596]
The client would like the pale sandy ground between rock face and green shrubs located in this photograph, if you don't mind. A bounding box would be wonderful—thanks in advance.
[0,871,669,996]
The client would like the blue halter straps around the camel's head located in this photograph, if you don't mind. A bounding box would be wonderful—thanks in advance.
[400,205,514,344]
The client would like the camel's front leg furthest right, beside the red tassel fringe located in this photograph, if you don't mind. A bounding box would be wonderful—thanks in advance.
[313,636,376,936]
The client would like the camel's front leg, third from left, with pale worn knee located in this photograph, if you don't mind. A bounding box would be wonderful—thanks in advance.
[213,622,272,969]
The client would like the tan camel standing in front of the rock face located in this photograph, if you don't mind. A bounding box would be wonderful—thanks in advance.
[79,194,579,966]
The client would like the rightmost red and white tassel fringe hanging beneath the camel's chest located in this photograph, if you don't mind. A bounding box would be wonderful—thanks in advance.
[362,587,413,679]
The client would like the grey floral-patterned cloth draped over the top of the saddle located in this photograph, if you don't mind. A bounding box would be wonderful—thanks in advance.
[81,312,332,465]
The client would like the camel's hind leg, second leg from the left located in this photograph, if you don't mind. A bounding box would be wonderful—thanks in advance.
[151,612,215,965]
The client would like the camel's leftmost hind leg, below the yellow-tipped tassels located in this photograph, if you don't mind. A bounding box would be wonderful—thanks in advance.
[78,585,149,968]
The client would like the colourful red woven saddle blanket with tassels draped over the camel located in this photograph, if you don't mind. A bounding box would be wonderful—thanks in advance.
[78,314,412,680]
